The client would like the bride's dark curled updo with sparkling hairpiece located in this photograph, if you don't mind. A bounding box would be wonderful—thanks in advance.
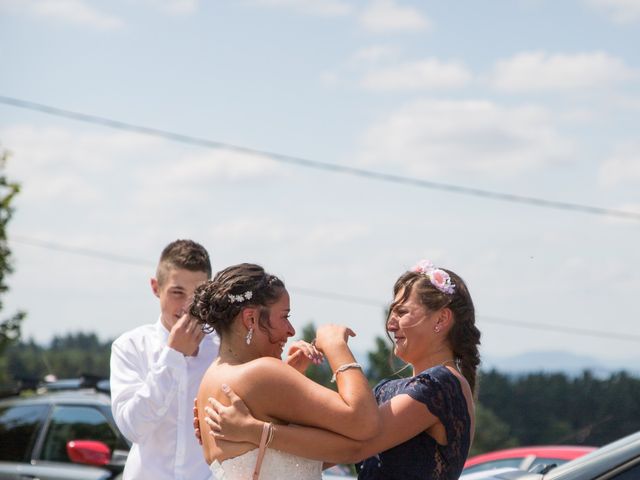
[189,263,285,338]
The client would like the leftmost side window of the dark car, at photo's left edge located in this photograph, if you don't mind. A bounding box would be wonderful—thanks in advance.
[0,405,48,462]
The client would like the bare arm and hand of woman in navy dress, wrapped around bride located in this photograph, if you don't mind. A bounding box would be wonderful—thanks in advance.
[205,384,439,463]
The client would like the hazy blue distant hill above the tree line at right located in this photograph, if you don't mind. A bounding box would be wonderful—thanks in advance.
[480,351,640,377]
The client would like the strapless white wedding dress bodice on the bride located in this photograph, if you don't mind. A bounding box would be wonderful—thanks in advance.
[210,448,322,480]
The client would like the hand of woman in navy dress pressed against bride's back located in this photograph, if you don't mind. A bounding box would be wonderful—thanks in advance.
[204,385,264,445]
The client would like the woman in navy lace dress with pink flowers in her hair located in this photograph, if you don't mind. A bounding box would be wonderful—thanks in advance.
[207,261,480,480]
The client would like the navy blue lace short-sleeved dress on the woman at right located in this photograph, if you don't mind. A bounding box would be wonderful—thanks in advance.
[358,365,471,480]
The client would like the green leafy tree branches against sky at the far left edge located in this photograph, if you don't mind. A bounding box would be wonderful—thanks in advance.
[0,148,25,376]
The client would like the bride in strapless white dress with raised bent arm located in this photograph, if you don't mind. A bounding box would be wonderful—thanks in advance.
[190,263,379,480]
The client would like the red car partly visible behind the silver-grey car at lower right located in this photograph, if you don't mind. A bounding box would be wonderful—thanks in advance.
[462,445,596,473]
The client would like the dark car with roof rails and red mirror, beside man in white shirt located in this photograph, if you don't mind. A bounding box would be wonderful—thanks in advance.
[0,379,130,480]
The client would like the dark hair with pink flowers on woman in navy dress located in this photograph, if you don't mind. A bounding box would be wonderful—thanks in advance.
[390,263,480,393]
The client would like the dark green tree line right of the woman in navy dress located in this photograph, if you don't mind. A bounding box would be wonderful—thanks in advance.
[478,370,640,446]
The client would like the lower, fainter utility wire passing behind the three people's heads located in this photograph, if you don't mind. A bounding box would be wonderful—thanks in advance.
[9,235,640,342]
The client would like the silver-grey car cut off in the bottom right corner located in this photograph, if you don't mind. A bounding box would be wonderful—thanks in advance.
[462,432,640,480]
